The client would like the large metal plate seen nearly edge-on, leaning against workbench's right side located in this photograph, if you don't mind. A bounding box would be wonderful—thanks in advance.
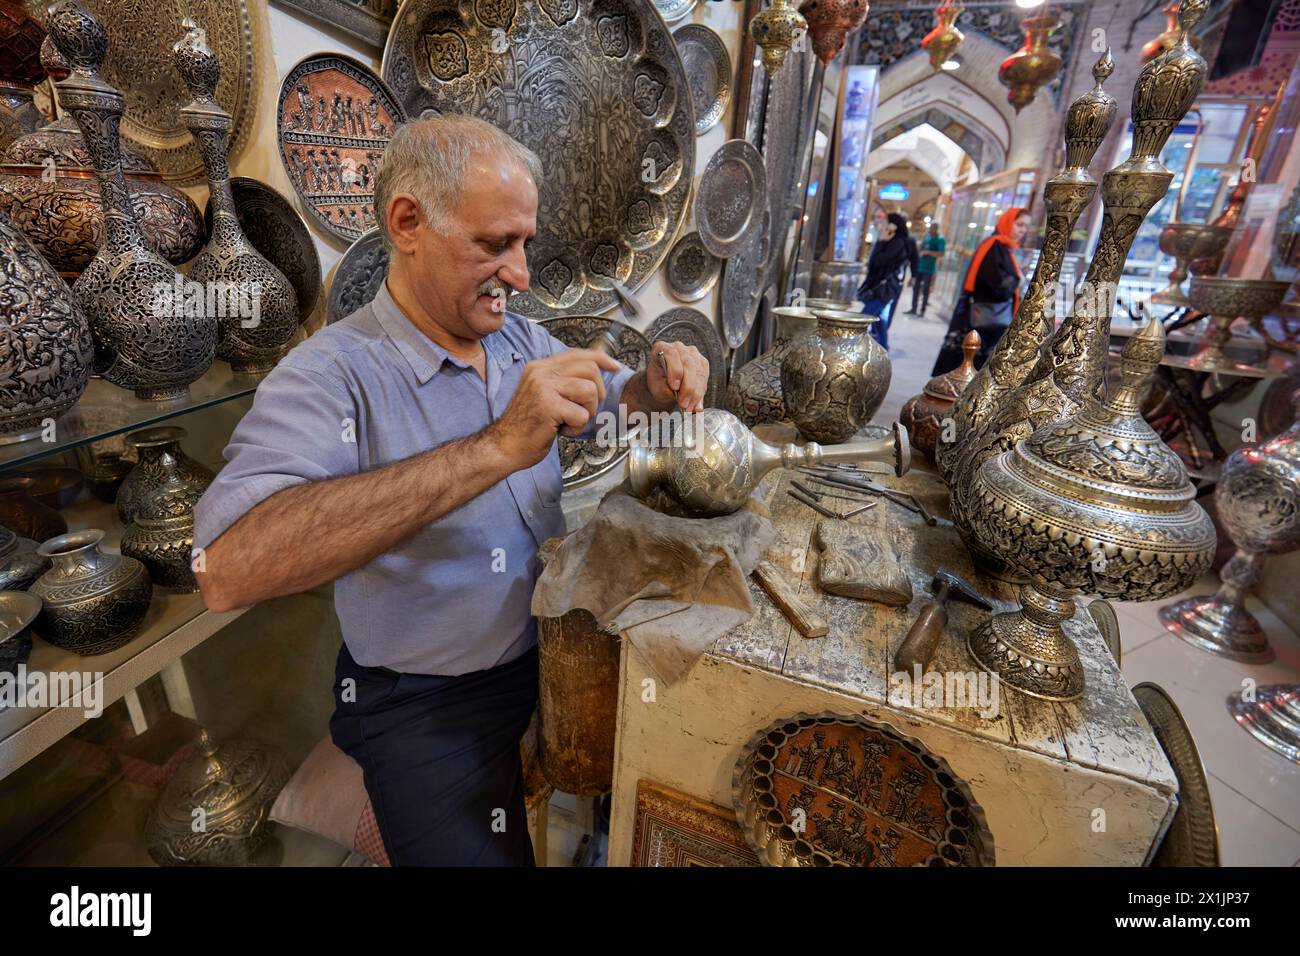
[1134,683,1219,866]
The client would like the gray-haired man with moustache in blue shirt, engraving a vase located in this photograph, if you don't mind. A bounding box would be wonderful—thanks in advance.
[195,117,709,865]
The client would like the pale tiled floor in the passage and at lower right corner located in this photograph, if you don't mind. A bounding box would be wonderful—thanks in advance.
[876,295,1300,866]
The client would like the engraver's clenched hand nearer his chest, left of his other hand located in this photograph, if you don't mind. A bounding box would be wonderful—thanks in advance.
[488,349,619,471]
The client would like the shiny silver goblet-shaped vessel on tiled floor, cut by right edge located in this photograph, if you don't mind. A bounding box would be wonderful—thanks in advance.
[1160,392,1300,663]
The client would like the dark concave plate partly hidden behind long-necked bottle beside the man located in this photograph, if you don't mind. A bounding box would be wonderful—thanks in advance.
[203,176,321,323]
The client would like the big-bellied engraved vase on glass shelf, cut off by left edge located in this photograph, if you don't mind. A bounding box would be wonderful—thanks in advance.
[0,212,95,445]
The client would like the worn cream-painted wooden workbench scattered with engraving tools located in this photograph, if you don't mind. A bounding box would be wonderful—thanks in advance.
[610,436,1178,866]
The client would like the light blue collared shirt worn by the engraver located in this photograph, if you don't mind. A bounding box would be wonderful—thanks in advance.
[194,286,632,675]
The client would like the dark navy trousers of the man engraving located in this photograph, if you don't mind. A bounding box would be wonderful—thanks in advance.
[330,644,537,866]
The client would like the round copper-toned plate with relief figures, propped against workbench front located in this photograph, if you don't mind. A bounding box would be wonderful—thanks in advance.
[732,714,993,866]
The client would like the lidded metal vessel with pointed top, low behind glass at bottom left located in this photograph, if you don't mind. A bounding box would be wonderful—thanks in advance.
[144,728,289,866]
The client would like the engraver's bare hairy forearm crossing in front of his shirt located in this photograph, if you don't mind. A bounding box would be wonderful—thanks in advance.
[196,427,512,610]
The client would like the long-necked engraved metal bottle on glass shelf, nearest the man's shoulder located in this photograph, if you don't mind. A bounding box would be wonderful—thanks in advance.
[173,18,298,372]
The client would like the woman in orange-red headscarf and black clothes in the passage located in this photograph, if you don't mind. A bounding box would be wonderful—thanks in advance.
[931,206,1030,375]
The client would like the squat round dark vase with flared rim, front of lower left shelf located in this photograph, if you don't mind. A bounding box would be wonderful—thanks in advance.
[30,528,153,657]
